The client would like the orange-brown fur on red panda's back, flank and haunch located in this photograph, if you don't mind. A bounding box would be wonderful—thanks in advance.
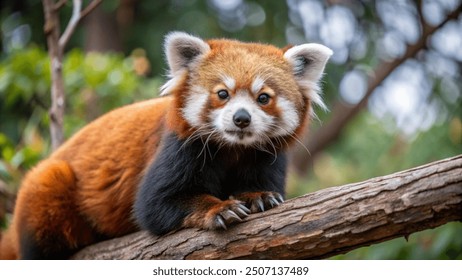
[0,97,172,259]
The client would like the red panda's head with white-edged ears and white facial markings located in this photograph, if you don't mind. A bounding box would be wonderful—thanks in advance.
[162,32,332,149]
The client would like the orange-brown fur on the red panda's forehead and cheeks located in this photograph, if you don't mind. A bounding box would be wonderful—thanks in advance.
[167,40,310,143]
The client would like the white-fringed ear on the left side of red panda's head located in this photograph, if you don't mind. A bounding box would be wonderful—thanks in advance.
[164,32,210,76]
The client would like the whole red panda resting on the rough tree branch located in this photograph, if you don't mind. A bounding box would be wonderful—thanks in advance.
[0,32,332,259]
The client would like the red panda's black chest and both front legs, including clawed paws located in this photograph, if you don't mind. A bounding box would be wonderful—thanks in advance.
[134,134,287,234]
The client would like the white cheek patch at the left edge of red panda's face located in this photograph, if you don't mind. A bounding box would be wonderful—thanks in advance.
[182,86,208,127]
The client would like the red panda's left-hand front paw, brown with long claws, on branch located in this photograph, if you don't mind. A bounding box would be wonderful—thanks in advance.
[184,199,250,230]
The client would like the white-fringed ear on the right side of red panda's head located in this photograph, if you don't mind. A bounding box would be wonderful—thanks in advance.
[284,44,333,83]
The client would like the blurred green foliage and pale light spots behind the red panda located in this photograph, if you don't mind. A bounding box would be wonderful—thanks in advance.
[0,0,462,259]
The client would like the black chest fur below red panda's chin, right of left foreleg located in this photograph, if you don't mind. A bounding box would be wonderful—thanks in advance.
[156,134,286,199]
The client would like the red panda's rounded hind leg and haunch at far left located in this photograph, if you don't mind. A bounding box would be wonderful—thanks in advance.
[0,159,97,259]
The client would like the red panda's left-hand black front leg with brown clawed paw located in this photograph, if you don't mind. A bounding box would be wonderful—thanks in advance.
[134,134,250,235]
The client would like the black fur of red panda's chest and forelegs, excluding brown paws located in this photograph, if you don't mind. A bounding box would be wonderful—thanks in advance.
[134,133,287,234]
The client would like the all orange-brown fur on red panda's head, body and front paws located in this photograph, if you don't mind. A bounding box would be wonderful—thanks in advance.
[0,36,328,259]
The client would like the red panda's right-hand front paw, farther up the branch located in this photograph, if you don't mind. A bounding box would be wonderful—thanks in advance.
[231,192,284,213]
